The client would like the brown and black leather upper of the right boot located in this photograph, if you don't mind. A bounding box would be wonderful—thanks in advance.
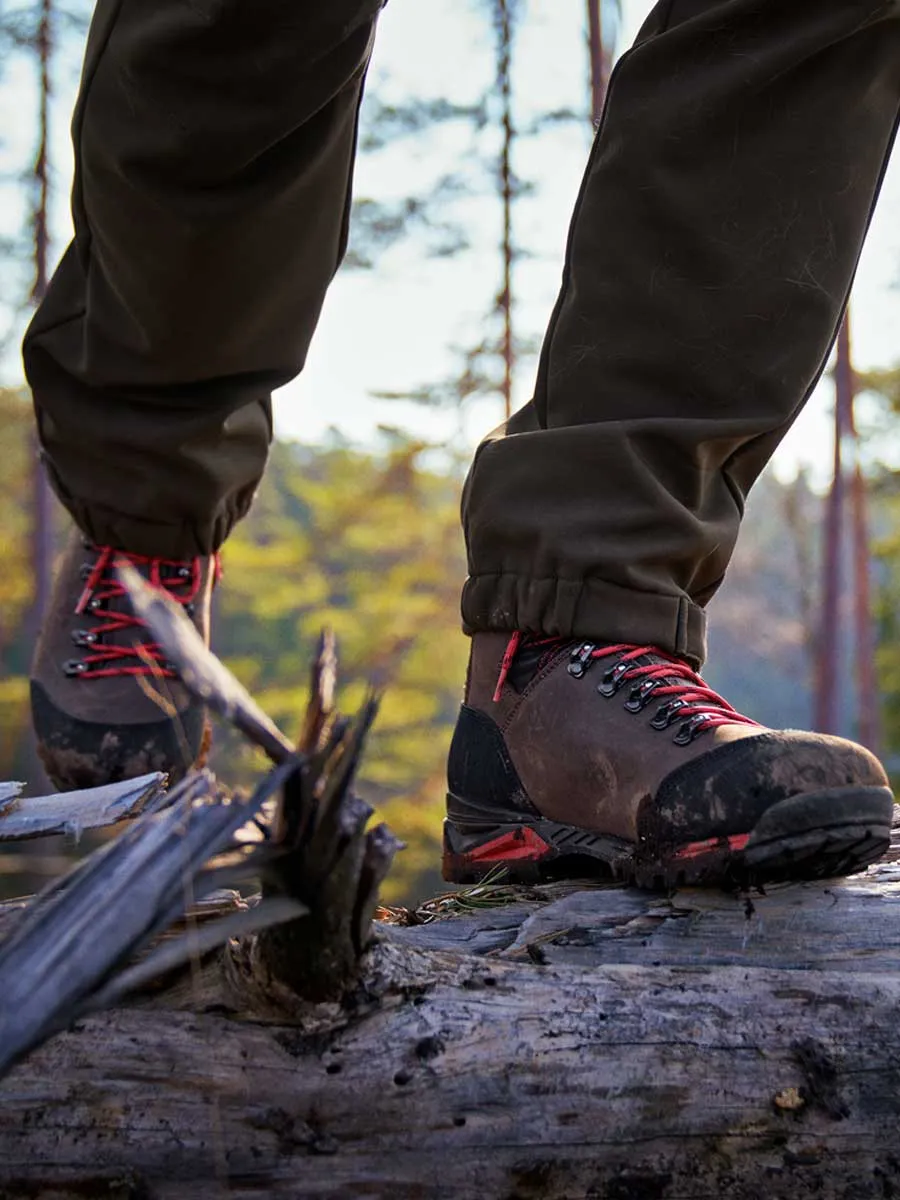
[466,634,888,840]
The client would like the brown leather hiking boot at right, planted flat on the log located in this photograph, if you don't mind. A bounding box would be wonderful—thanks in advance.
[444,634,893,887]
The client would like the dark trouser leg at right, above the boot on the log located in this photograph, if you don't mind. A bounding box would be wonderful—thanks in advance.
[463,0,900,661]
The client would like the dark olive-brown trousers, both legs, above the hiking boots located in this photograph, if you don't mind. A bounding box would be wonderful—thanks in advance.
[24,0,900,661]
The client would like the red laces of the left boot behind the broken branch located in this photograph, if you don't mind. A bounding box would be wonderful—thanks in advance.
[65,546,214,679]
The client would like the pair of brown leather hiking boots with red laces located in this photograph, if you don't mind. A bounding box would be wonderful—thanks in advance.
[31,536,893,887]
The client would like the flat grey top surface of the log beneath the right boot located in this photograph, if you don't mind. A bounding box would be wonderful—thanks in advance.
[388,863,900,969]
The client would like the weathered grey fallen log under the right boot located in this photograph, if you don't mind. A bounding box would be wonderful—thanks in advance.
[0,844,900,1200]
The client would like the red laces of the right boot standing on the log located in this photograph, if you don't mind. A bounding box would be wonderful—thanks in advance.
[493,632,760,740]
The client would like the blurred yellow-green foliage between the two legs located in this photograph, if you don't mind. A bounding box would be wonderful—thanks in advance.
[207,440,467,895]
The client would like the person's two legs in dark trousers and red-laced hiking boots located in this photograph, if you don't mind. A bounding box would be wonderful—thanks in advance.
[24,0,900,882]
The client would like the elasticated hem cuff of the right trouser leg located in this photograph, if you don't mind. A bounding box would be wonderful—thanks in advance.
[462,574,707,667]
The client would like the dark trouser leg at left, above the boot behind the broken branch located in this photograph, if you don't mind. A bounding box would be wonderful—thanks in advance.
[24,0,383,557]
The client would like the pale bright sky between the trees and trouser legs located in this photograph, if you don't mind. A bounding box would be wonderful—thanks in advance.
[0,0,900,480]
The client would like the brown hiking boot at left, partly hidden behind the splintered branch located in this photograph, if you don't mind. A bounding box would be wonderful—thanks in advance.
[31,533,217,790]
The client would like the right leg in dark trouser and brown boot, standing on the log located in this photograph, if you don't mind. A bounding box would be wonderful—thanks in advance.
[449,0,900,876]
